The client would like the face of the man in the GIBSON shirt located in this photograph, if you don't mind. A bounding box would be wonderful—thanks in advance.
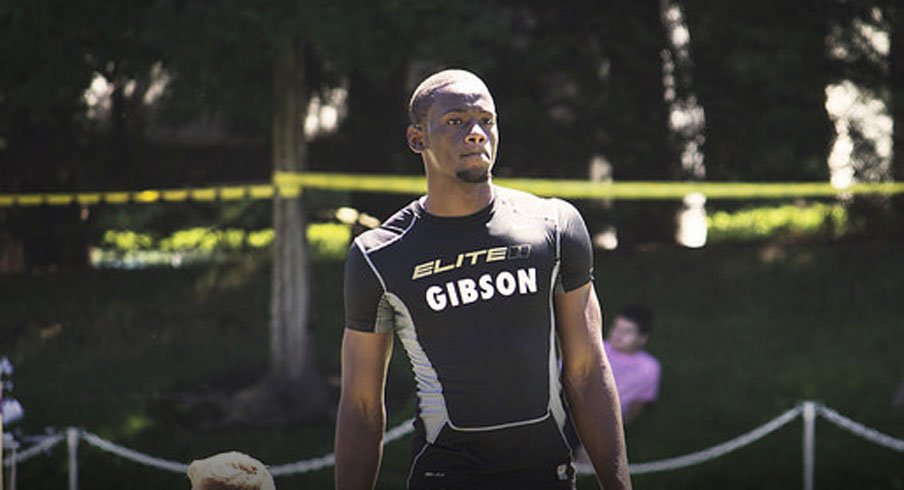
[409,81,499,183]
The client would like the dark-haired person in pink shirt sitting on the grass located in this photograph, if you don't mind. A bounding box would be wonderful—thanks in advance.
[604,305,660,424]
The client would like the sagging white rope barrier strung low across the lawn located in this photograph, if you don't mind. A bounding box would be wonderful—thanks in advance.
[3,402,904,482]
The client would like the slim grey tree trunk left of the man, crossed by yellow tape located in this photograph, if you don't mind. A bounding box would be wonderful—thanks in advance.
[230,44,333,425]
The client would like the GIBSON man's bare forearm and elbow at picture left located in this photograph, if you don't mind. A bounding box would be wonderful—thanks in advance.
[336,329,392,490]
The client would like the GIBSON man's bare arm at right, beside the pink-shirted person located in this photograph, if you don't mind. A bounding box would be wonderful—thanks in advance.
[556,282,631,490]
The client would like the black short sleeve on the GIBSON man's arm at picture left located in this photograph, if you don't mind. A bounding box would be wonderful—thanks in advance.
[345,244,383,332]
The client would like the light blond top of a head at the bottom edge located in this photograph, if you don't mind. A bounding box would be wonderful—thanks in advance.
[188,451,276,490]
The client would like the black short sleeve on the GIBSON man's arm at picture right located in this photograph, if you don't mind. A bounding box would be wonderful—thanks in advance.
[556,200,593,292]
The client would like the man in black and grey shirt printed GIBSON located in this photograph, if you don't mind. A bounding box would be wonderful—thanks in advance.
[336,70,630,490]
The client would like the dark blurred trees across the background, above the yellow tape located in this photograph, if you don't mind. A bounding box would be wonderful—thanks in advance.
[0,0,904,263]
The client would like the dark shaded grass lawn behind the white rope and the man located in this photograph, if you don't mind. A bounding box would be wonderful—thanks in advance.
[0,241,904,490]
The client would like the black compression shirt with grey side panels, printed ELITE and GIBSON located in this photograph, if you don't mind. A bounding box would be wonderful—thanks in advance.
[345,186,592,489]
